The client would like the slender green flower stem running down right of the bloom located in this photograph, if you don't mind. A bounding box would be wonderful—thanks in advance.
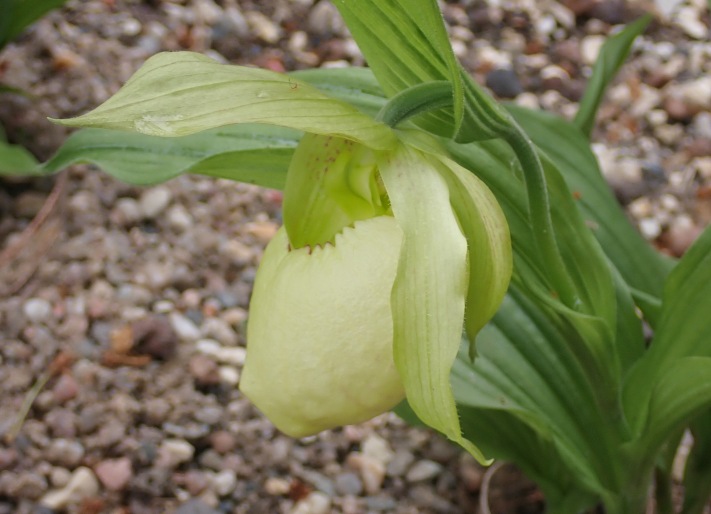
[502,124,580,310]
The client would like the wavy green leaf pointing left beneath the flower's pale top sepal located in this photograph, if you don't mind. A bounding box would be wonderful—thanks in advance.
[42,124,301,189]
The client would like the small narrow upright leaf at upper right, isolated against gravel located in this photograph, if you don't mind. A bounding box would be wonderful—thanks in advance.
[573,14,652,137]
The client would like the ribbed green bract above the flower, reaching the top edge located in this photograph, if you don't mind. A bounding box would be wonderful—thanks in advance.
[335,0,514,142]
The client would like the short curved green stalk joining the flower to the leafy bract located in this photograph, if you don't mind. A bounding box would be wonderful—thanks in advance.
[376,80,454,128]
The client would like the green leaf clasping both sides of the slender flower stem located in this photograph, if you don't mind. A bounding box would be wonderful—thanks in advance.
[447,141,634,402]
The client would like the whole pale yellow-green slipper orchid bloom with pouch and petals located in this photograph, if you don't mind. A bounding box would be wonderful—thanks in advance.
[55,52,511,458]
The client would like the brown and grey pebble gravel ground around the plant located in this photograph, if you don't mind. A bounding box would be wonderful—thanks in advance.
[0,0,711,514]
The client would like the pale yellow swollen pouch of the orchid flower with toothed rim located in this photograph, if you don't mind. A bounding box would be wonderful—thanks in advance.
[240,216,404,437]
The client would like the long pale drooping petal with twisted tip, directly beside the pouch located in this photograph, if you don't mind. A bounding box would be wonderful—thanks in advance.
[378,141,484,461]
